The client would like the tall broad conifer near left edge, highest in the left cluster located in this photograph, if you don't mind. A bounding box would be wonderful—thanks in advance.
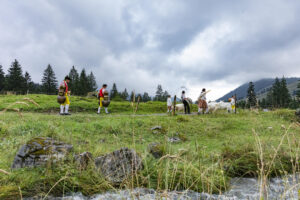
[5,60,25,93]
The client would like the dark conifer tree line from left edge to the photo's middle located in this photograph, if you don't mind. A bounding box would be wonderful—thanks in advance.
[0,59,169,102]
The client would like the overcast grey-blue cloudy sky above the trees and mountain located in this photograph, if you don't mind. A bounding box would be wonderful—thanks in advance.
[0,0,300,100]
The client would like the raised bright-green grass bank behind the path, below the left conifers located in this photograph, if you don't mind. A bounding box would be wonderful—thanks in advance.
[0,94,197,114]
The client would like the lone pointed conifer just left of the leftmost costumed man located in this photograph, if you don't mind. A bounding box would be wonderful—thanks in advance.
[42,64,57,94]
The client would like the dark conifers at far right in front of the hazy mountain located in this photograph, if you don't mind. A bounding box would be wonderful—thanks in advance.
[237,77,300,109]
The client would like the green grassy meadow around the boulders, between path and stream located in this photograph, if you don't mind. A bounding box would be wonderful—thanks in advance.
[0,96,300,199]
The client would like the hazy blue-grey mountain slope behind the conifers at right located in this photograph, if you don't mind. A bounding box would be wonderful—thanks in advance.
[217,77,300,101]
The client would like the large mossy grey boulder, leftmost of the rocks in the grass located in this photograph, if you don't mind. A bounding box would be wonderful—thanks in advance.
[11,137,73,169]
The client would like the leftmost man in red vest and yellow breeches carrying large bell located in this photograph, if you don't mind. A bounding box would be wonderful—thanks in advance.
[58,76,71,115]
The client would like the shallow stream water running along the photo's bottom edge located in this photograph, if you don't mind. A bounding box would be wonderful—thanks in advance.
[27,176,300,200]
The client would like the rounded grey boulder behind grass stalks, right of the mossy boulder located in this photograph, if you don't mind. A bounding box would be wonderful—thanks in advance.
[95,148,143,184]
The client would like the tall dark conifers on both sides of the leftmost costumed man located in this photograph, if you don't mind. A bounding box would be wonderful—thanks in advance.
[0,60,97,95]
